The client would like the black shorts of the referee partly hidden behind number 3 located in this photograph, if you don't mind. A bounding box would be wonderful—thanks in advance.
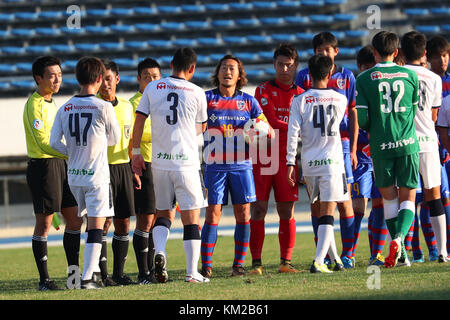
[134,162,156,214]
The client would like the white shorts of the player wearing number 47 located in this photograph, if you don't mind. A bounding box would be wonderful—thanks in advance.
[70,184,114,218]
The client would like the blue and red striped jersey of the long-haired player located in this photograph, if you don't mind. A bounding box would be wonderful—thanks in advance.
[204,88,262,171]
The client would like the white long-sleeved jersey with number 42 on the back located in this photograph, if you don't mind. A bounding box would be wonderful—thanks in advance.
[286,89,347,176]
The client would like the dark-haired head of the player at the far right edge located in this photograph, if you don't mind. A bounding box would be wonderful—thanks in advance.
[426,36,450,76]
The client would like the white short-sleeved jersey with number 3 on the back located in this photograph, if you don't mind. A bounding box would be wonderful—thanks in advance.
[136,76,207,171]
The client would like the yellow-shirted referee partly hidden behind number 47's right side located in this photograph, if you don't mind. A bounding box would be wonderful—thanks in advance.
[98,60,135,286]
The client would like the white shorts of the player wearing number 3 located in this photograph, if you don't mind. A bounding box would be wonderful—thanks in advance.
[152,168,208,210]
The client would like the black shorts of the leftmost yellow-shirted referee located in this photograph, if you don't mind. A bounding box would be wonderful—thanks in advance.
[27,158,77,214]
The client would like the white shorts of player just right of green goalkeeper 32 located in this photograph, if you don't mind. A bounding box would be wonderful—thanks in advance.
[419,151,442,189]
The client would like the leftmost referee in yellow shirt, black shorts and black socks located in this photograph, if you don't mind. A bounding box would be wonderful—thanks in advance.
[23,56,83,291]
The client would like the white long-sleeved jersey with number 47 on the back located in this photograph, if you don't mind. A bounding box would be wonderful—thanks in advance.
[50,95,121,187]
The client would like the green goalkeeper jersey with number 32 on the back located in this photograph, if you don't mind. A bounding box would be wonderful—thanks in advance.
[356,62,420,159]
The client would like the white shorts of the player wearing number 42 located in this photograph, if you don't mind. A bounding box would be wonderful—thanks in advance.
[304,173,350,203]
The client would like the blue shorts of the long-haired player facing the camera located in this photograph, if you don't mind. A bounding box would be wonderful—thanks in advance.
[205,167,256,205]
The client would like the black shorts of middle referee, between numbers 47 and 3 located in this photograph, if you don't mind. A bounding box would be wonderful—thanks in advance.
[109,163,135,219]
